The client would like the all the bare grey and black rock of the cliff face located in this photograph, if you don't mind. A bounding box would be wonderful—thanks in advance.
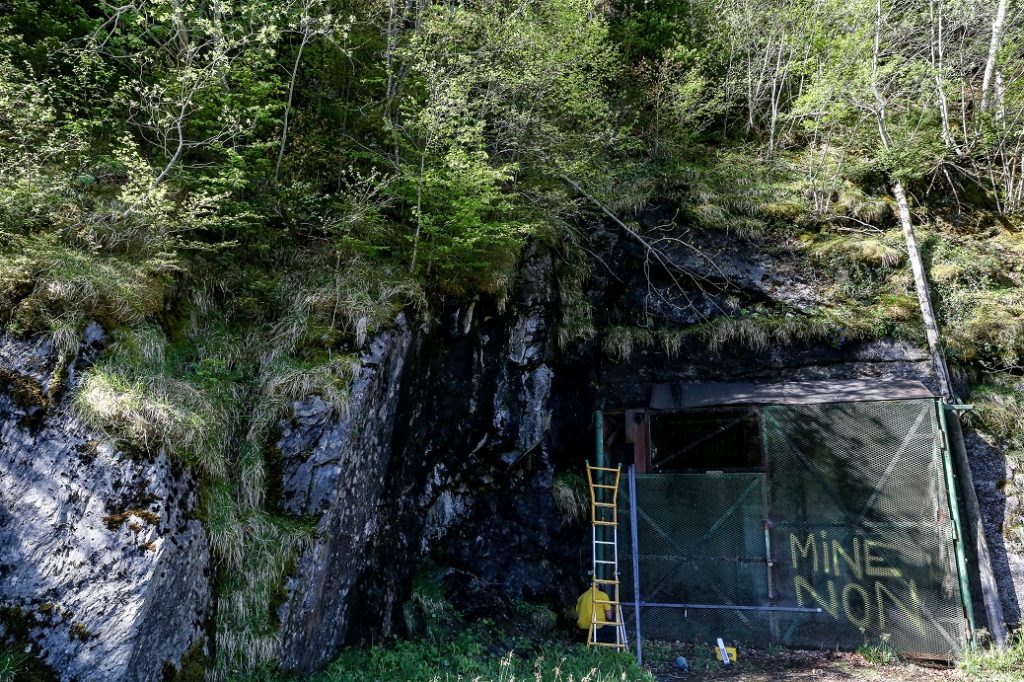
[0,215,1024,680]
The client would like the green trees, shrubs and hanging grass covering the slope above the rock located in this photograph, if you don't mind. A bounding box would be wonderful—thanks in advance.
[0,0,1024,670]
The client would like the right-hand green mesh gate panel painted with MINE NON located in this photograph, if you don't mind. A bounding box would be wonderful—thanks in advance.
[762,400,967,655]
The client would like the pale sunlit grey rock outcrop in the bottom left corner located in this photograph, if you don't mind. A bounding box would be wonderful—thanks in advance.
[0,327,210,682]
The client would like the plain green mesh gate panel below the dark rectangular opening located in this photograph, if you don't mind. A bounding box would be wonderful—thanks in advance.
[620,473,769,639]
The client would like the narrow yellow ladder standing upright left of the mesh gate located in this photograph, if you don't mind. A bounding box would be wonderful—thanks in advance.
[587,462,628,651]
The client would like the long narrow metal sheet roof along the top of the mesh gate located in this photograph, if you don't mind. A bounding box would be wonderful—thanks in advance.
[650,379,935,410]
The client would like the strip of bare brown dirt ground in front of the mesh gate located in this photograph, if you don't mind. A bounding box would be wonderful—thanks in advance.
[644,644,968,682]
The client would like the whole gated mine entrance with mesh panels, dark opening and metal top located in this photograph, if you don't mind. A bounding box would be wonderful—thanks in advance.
[605,381,971,657]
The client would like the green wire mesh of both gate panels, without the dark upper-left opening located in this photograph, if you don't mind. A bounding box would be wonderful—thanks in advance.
[618,400,967,656]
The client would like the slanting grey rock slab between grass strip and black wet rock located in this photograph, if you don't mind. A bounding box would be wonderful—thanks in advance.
[279,317,413,672]
